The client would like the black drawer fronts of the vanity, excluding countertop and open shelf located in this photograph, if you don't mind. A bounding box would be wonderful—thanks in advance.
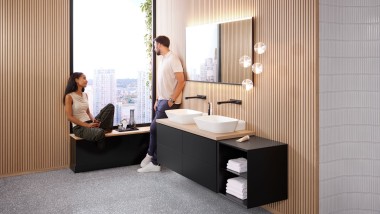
[157,124,217,192]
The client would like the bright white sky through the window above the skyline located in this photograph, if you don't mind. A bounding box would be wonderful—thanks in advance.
[73,0,147,79]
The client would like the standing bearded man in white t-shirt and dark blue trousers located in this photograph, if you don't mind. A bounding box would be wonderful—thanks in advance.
[137,36,185,172]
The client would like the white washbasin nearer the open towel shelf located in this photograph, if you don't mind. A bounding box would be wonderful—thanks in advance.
[194,115,239,133]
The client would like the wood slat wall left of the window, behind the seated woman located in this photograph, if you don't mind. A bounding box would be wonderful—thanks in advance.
[0,0,70,177]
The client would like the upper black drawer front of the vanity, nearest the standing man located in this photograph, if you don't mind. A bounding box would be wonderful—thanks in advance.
[157,123,182,154]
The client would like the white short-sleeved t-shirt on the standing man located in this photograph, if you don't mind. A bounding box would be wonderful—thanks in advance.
[157,51,183,104]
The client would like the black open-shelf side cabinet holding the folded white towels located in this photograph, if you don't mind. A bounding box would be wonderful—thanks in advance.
[218,136,288,208]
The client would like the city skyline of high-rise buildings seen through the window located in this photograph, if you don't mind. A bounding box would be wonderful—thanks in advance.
[85,69,152,126]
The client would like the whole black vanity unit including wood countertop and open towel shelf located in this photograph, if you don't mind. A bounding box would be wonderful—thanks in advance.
[157,120,288,208]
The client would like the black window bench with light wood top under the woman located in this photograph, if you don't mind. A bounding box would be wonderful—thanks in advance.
[70,126,149,173]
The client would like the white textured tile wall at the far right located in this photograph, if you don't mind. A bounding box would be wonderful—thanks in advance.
[319,0,380,214]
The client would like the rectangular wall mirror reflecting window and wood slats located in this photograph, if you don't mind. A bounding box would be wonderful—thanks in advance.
[186,18,253,84]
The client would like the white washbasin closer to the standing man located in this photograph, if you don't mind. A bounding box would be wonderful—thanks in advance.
[165,109,203,124]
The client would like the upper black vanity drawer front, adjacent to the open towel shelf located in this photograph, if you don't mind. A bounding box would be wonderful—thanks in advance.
[182,132,217,166]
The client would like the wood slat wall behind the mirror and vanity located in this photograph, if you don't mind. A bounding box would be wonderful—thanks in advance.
[157,0,319,214]
